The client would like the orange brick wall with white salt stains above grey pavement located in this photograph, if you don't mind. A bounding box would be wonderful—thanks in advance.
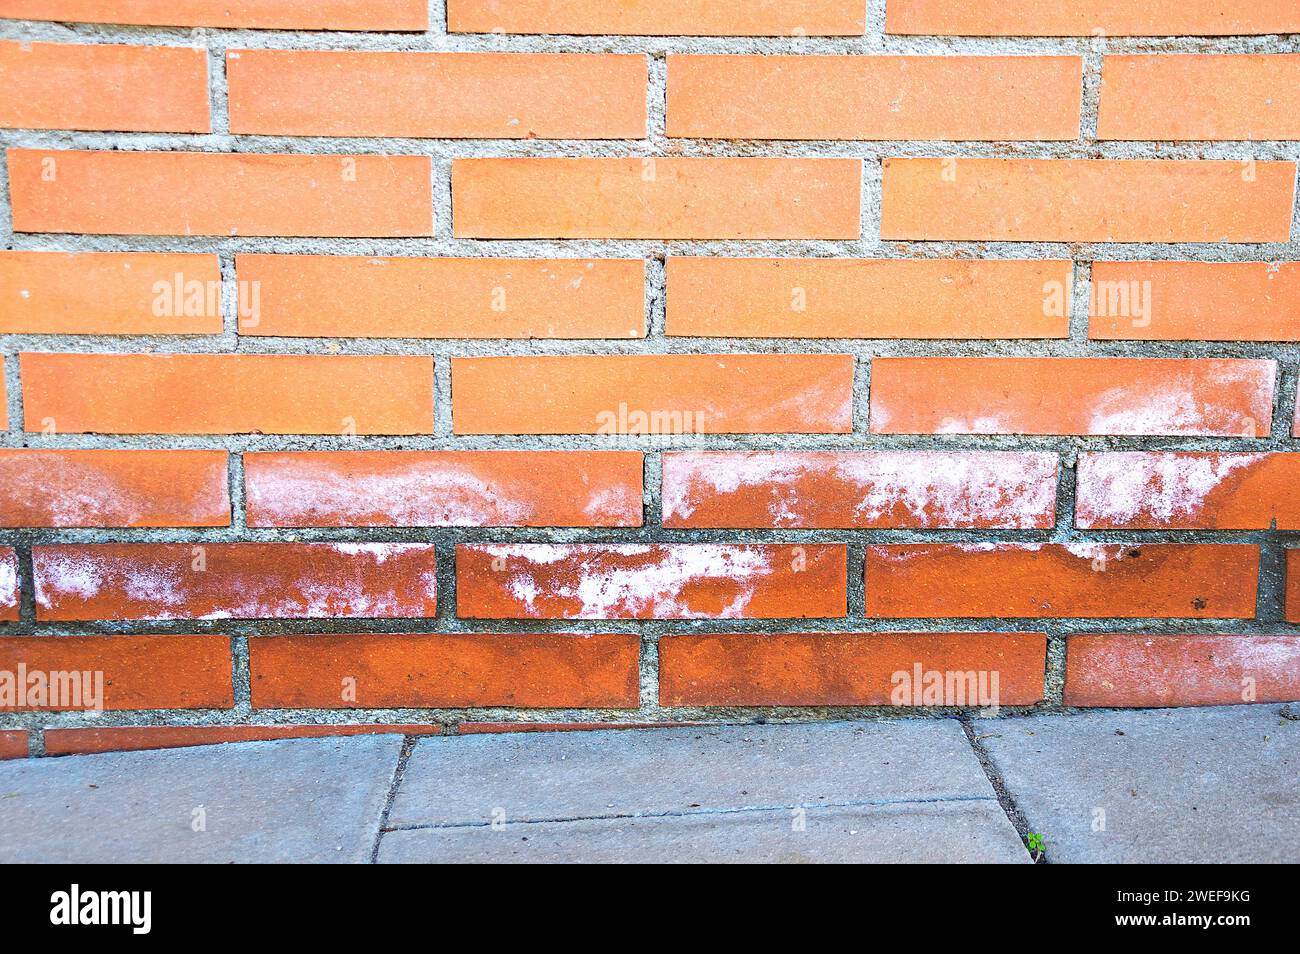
[0,0,1300,758]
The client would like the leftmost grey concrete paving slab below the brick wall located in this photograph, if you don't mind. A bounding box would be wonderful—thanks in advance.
[0,736,402,863]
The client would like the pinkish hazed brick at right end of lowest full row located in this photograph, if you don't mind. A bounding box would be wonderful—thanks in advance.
[1065,633,1300,707]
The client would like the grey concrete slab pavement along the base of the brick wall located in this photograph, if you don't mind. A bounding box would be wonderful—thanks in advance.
[0,704,1300,864]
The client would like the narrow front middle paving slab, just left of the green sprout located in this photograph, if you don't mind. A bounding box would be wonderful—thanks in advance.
[380,801,1030,864]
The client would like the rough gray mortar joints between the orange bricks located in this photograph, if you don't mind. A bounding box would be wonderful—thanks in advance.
[0,0,1300,755]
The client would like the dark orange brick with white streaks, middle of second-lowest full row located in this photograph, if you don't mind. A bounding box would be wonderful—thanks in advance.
[456,543,848,620]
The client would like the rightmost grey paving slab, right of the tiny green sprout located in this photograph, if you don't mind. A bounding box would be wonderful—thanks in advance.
[976,704,1300,863]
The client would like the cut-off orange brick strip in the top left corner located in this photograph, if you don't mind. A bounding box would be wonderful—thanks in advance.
[0,0,429,31]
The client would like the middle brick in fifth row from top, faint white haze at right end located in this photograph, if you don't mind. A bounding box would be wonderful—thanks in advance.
[451,355,853,439]
